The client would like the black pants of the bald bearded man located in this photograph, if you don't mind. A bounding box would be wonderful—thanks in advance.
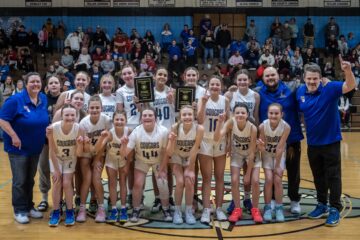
[286,142,301,202]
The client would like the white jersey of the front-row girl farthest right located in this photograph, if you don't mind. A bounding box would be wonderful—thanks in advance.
[263,119,286,156]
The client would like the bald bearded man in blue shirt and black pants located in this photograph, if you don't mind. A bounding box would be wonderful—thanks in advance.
[257,67,304,214]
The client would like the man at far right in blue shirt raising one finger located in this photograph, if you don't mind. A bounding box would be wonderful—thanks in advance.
[296,56,355,226]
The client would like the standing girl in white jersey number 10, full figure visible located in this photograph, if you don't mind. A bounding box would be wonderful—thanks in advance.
[197,76,230,223]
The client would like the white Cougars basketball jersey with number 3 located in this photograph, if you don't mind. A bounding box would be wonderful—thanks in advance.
[52,121,79,161]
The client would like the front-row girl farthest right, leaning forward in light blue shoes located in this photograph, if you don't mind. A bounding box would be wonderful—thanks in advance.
[258,103,290,222]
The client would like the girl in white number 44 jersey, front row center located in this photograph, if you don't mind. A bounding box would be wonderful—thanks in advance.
[121,107,172,222]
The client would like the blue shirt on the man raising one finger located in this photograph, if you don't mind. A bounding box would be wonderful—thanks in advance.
[296,81,343,146]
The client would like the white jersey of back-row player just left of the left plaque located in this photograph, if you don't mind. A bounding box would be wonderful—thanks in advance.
[116,85,140,128]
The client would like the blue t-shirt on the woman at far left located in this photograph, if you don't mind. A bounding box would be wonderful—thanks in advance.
[0,90,49,156]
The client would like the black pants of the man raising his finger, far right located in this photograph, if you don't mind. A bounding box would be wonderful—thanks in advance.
[308,142,342,211]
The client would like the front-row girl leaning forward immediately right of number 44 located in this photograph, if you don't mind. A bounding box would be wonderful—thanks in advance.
[167,106,204,224]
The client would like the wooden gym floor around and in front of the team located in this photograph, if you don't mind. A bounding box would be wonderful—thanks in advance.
[0,132,360,240]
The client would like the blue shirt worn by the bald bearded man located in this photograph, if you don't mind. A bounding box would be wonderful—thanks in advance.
[259,81,304,144]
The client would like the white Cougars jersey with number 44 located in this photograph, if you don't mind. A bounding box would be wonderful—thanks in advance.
[128,124,168,164]
